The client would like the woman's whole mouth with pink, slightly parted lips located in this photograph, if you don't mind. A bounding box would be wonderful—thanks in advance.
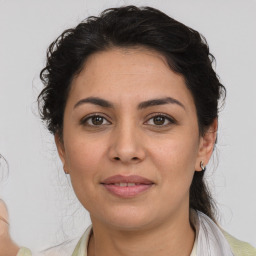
[101,175,154,198]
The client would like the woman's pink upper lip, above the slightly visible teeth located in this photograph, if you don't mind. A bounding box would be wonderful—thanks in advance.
[101,175,154,185]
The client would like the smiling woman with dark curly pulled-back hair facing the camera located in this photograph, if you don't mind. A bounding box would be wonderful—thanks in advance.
[1,6,256,256]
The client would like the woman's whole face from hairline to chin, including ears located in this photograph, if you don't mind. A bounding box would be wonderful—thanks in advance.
[56,48,214,230]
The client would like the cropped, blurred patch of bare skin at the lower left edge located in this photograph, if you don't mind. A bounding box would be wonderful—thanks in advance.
[0,199,19,256]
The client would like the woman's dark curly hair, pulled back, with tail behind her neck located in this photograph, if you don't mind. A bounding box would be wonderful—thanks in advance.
[38,6,225,219]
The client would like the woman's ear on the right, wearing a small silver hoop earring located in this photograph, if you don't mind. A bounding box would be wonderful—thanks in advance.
[195,118,218,171]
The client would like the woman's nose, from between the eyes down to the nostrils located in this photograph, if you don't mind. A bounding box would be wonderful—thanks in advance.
[108,125,146,164]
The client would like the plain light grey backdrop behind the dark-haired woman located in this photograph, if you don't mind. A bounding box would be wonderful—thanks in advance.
[0,0,256,249]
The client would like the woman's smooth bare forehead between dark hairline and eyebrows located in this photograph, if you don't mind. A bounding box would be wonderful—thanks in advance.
[70,48,193,110]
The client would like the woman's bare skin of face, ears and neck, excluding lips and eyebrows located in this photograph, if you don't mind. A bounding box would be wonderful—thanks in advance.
[55,48,217,256]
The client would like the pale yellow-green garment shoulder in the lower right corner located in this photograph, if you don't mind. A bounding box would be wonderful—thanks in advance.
[222,230,256,256]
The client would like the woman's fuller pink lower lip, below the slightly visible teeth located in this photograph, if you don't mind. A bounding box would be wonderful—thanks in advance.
[103,184,153,198]
